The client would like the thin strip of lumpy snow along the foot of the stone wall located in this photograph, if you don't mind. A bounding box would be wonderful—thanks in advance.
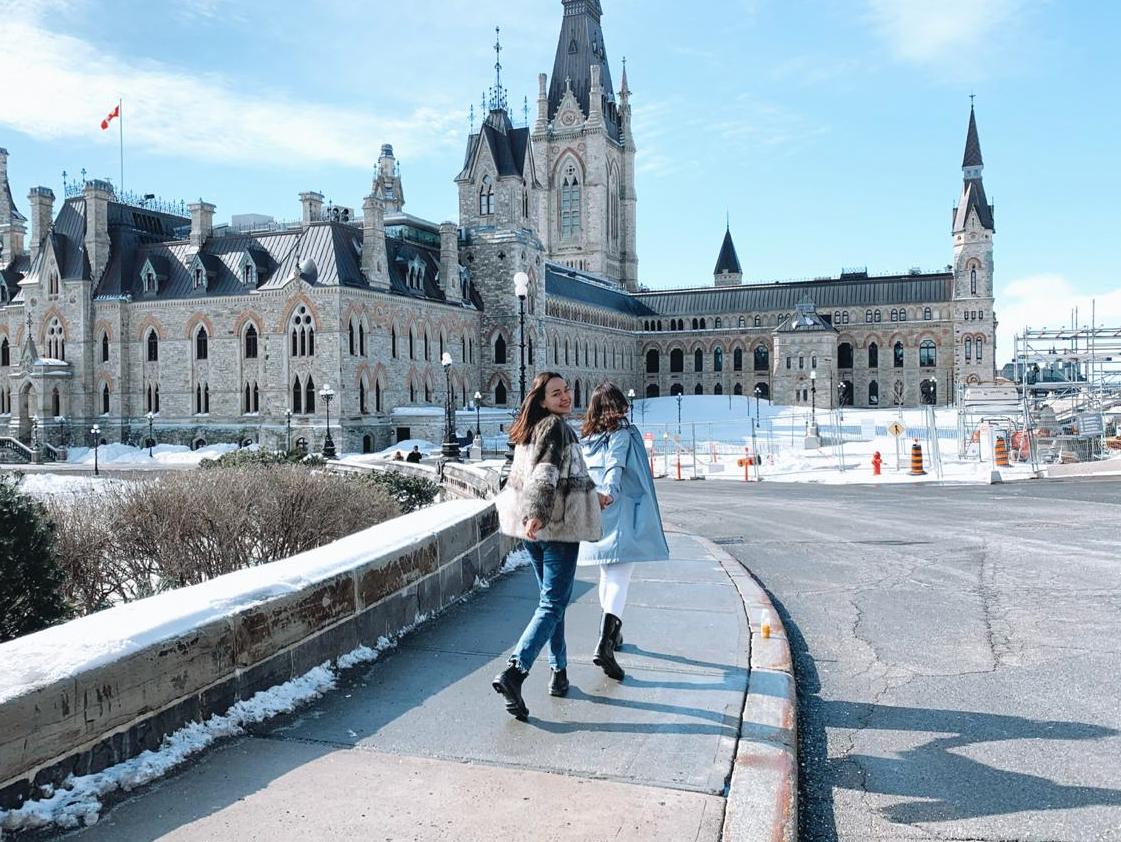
[0,540,529,836]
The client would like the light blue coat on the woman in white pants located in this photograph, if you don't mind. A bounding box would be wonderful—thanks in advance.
[577,422,669,565]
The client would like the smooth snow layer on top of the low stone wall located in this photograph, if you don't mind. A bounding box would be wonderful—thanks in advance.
[0,500,490,702]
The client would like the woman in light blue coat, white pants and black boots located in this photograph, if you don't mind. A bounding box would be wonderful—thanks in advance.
[577,382,669,681]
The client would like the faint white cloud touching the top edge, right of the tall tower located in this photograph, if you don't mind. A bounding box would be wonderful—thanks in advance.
[868,0,1034,65]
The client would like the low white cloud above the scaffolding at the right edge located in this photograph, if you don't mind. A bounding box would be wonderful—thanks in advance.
[995,272,1121,366]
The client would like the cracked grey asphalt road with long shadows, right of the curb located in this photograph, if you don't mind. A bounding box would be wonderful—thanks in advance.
[658,479,1121,842]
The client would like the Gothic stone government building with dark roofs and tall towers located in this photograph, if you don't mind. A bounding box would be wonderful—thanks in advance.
[0,0,997,451]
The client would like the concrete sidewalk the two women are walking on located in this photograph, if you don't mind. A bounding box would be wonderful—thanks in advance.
[68,534,750,842]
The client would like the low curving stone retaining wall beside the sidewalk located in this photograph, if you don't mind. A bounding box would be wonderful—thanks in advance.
[0,502,513,808]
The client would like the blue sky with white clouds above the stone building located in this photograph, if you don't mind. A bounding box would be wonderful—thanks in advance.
[0,0,1121,360]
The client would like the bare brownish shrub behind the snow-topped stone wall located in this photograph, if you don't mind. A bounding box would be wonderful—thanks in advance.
[52,464,401,612]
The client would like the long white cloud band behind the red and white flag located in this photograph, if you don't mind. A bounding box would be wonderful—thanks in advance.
[0,14,466,167]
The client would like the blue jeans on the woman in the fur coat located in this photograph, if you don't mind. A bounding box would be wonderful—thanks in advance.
[510,540,580,673]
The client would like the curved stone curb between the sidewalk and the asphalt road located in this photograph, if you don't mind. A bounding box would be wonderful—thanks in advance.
[679,529,798,842]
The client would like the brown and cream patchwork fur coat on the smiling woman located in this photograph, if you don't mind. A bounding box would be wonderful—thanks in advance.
[494,415,603,543]
